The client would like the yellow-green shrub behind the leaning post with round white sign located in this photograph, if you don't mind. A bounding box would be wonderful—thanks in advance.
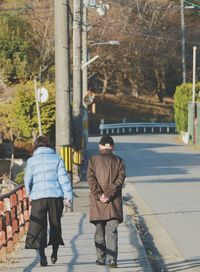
[0,81,55,142]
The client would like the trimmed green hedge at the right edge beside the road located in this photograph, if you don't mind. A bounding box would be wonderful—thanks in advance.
[174,82,200,133]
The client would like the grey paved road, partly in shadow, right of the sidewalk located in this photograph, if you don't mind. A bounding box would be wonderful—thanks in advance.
[90,135,200,272]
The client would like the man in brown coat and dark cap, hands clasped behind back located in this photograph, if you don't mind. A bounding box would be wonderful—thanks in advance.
[87,136,125,268]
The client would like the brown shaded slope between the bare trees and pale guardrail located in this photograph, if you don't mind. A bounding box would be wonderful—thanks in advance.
[89,95,174,134]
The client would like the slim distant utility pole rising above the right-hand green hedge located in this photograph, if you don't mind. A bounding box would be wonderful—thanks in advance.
[181,0,186,83]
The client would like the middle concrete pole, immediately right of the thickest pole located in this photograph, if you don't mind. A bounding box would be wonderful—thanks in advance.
[73,0,82,150]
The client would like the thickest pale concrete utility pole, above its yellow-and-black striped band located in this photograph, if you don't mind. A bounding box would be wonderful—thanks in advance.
[54,0,71,152]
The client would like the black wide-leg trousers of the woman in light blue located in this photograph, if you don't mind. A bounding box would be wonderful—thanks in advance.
[25,198,64,249]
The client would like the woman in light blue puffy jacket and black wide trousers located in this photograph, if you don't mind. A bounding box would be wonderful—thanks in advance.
[24,136,73,266]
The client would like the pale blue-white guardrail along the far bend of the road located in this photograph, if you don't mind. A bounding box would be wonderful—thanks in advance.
[99,123,176,135]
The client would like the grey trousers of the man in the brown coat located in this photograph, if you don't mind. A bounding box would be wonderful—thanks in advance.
[94,219,119,263]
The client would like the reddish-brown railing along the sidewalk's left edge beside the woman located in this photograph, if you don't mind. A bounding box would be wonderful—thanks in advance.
[0,185,30,259]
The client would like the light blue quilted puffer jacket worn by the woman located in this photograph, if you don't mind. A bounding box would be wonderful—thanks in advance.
[24,147,72,200]
